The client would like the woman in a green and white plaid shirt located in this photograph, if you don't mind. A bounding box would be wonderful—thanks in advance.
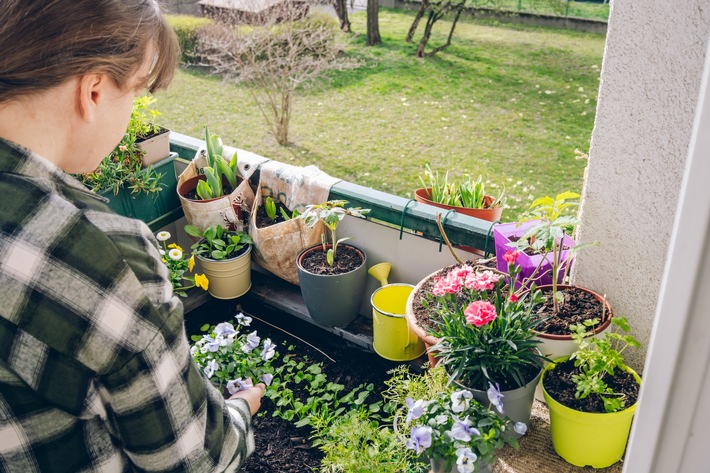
[0,0,264,473]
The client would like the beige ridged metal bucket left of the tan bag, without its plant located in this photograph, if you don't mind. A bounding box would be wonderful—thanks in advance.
[197,245,251,299]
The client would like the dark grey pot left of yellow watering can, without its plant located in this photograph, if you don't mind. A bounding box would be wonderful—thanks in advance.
[296,244,367,327]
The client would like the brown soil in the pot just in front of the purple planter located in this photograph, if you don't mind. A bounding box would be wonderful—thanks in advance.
[535,287,609,335]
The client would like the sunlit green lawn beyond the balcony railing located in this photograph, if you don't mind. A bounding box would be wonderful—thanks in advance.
[157,10,604,221]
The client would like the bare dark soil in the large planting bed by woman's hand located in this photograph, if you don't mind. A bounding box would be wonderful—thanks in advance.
[185,296,398,473]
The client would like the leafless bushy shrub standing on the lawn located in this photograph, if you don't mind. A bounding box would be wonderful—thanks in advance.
[198,0,354,145]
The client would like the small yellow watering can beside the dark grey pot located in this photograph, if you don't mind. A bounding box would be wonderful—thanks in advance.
[367,263,426,361]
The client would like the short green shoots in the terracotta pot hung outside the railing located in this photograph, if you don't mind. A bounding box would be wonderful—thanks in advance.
[419,164,505,209]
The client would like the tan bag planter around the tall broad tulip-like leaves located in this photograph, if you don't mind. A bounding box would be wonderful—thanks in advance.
[177,146,256,232]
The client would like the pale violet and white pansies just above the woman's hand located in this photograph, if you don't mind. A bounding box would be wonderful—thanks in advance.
[190,313,278,394]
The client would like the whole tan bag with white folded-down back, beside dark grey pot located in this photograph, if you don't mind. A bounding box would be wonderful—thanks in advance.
[249,161,338,285]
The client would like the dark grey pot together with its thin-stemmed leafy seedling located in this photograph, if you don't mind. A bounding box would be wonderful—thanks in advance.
[296,200,370,327]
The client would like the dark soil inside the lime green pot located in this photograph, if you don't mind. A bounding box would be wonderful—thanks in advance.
[543,360,640,412]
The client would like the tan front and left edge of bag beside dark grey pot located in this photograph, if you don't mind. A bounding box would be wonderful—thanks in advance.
[249,181,325,285]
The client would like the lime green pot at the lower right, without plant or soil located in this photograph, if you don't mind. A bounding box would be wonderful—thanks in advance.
[542,357,641,468]
